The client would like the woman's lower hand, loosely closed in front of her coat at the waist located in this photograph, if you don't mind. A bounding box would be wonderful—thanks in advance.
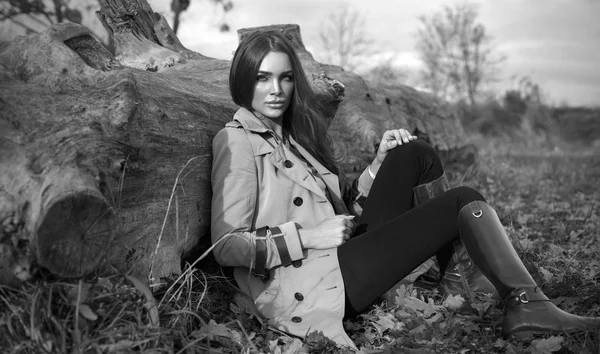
[298,215,354,250]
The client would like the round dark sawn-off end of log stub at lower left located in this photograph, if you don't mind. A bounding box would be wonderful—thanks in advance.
[37,193,115,277]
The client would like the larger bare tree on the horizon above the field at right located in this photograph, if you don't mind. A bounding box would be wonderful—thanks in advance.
[416,2,505,109]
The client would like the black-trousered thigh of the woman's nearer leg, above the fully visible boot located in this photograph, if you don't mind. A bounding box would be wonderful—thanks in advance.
[338,185,485,312]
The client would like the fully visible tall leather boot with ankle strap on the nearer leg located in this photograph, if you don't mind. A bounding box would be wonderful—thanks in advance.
[458,201,600,336]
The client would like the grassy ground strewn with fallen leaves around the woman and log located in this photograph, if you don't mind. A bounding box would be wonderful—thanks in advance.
[0,134,600,354]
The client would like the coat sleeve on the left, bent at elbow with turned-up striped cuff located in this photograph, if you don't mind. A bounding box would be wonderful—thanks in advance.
[211,127,304,276]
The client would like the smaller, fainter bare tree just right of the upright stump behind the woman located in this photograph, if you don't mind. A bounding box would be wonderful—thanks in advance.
[319,5,373,70]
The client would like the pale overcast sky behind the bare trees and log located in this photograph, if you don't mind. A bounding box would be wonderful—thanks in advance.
[149,0,600,106]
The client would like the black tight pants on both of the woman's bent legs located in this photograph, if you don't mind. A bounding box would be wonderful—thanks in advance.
[338,140,485,315]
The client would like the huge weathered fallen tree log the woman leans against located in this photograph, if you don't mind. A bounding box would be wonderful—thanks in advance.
[0,0,474,284]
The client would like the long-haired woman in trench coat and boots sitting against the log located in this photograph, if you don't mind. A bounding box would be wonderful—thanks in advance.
[212,32,600,347]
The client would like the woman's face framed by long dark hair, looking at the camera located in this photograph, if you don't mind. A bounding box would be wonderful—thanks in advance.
[252,52,294,119]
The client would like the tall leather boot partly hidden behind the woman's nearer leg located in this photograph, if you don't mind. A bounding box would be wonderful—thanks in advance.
[413,172,496,301]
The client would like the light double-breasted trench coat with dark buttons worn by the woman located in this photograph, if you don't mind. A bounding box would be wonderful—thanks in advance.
[211,108,373,348]
